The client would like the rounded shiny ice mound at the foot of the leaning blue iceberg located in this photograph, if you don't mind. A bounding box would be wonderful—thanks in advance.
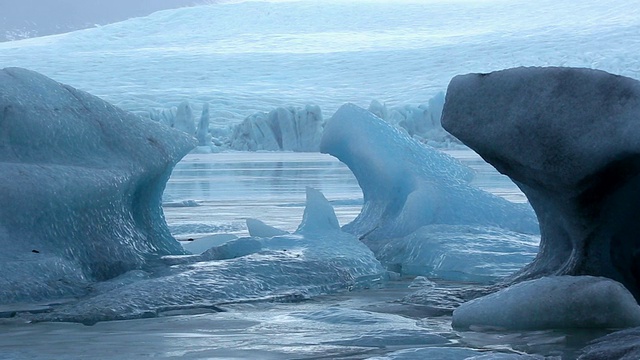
[376,225,539,283]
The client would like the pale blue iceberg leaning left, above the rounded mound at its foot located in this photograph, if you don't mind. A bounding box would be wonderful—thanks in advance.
[320,104,537,243]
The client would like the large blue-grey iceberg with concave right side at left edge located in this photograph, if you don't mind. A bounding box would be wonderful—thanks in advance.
[0,68,194,303]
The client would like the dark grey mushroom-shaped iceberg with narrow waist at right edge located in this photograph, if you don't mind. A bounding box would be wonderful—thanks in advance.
[443,68,640,299]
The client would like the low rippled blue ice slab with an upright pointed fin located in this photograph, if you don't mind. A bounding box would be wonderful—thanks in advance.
[37,189,385,324]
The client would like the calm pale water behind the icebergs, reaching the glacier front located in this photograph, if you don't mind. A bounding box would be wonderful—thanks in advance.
[164,150,526,239]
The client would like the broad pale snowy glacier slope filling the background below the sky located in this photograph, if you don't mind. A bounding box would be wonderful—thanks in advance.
[0,0,640,122]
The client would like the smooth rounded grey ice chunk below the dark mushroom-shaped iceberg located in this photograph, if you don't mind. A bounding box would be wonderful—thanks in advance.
[453,276,640,330]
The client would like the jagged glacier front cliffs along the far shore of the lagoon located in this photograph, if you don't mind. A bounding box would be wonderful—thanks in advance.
[137,92,460,152]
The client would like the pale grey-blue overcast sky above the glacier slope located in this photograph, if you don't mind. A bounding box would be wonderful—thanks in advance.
[0,0,210,41]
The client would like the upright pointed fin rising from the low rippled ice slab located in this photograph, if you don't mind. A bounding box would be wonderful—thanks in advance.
[296,187,340,233]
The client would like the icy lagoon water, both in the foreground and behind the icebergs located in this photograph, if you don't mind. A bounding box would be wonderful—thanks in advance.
[0,150,603,359]
